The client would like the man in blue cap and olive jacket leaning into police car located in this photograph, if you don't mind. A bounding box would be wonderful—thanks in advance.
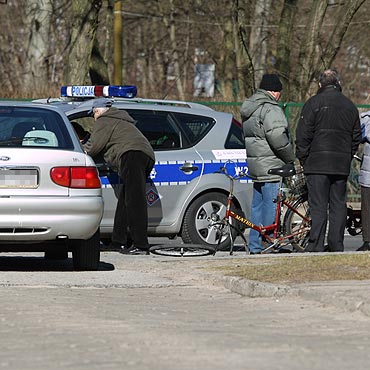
[84,98,155,255]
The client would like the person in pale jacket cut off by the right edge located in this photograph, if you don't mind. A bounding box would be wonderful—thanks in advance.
[357,111,370,252]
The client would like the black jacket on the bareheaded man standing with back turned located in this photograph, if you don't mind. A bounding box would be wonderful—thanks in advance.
[296,85,361,176]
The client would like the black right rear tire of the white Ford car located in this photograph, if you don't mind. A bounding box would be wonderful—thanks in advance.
[72,230,100,271]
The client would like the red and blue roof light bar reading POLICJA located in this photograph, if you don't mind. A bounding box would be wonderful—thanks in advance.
[60,85,137,98]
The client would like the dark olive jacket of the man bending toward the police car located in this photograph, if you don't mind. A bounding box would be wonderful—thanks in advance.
[84,107,155,172]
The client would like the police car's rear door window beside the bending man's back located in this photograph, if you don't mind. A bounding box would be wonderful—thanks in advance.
[128,110,182,150]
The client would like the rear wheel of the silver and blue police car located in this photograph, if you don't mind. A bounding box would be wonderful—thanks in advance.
[181,192,240,250]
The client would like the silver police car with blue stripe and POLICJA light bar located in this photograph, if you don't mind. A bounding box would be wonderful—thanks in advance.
[34,86,252,248]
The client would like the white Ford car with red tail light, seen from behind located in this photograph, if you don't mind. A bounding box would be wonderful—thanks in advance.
[0,101,104,270]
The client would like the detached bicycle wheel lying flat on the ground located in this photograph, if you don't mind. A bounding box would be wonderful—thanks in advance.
[149,244,216,257]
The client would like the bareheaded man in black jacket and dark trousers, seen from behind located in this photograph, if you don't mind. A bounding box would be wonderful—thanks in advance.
[296,69,361,252]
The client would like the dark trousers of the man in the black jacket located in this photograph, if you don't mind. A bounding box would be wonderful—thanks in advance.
[306,174,347,252]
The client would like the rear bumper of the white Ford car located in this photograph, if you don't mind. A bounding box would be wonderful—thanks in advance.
[0,197,103,243]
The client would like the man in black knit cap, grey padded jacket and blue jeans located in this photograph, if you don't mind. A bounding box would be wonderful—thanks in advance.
[240,74,295,254]
